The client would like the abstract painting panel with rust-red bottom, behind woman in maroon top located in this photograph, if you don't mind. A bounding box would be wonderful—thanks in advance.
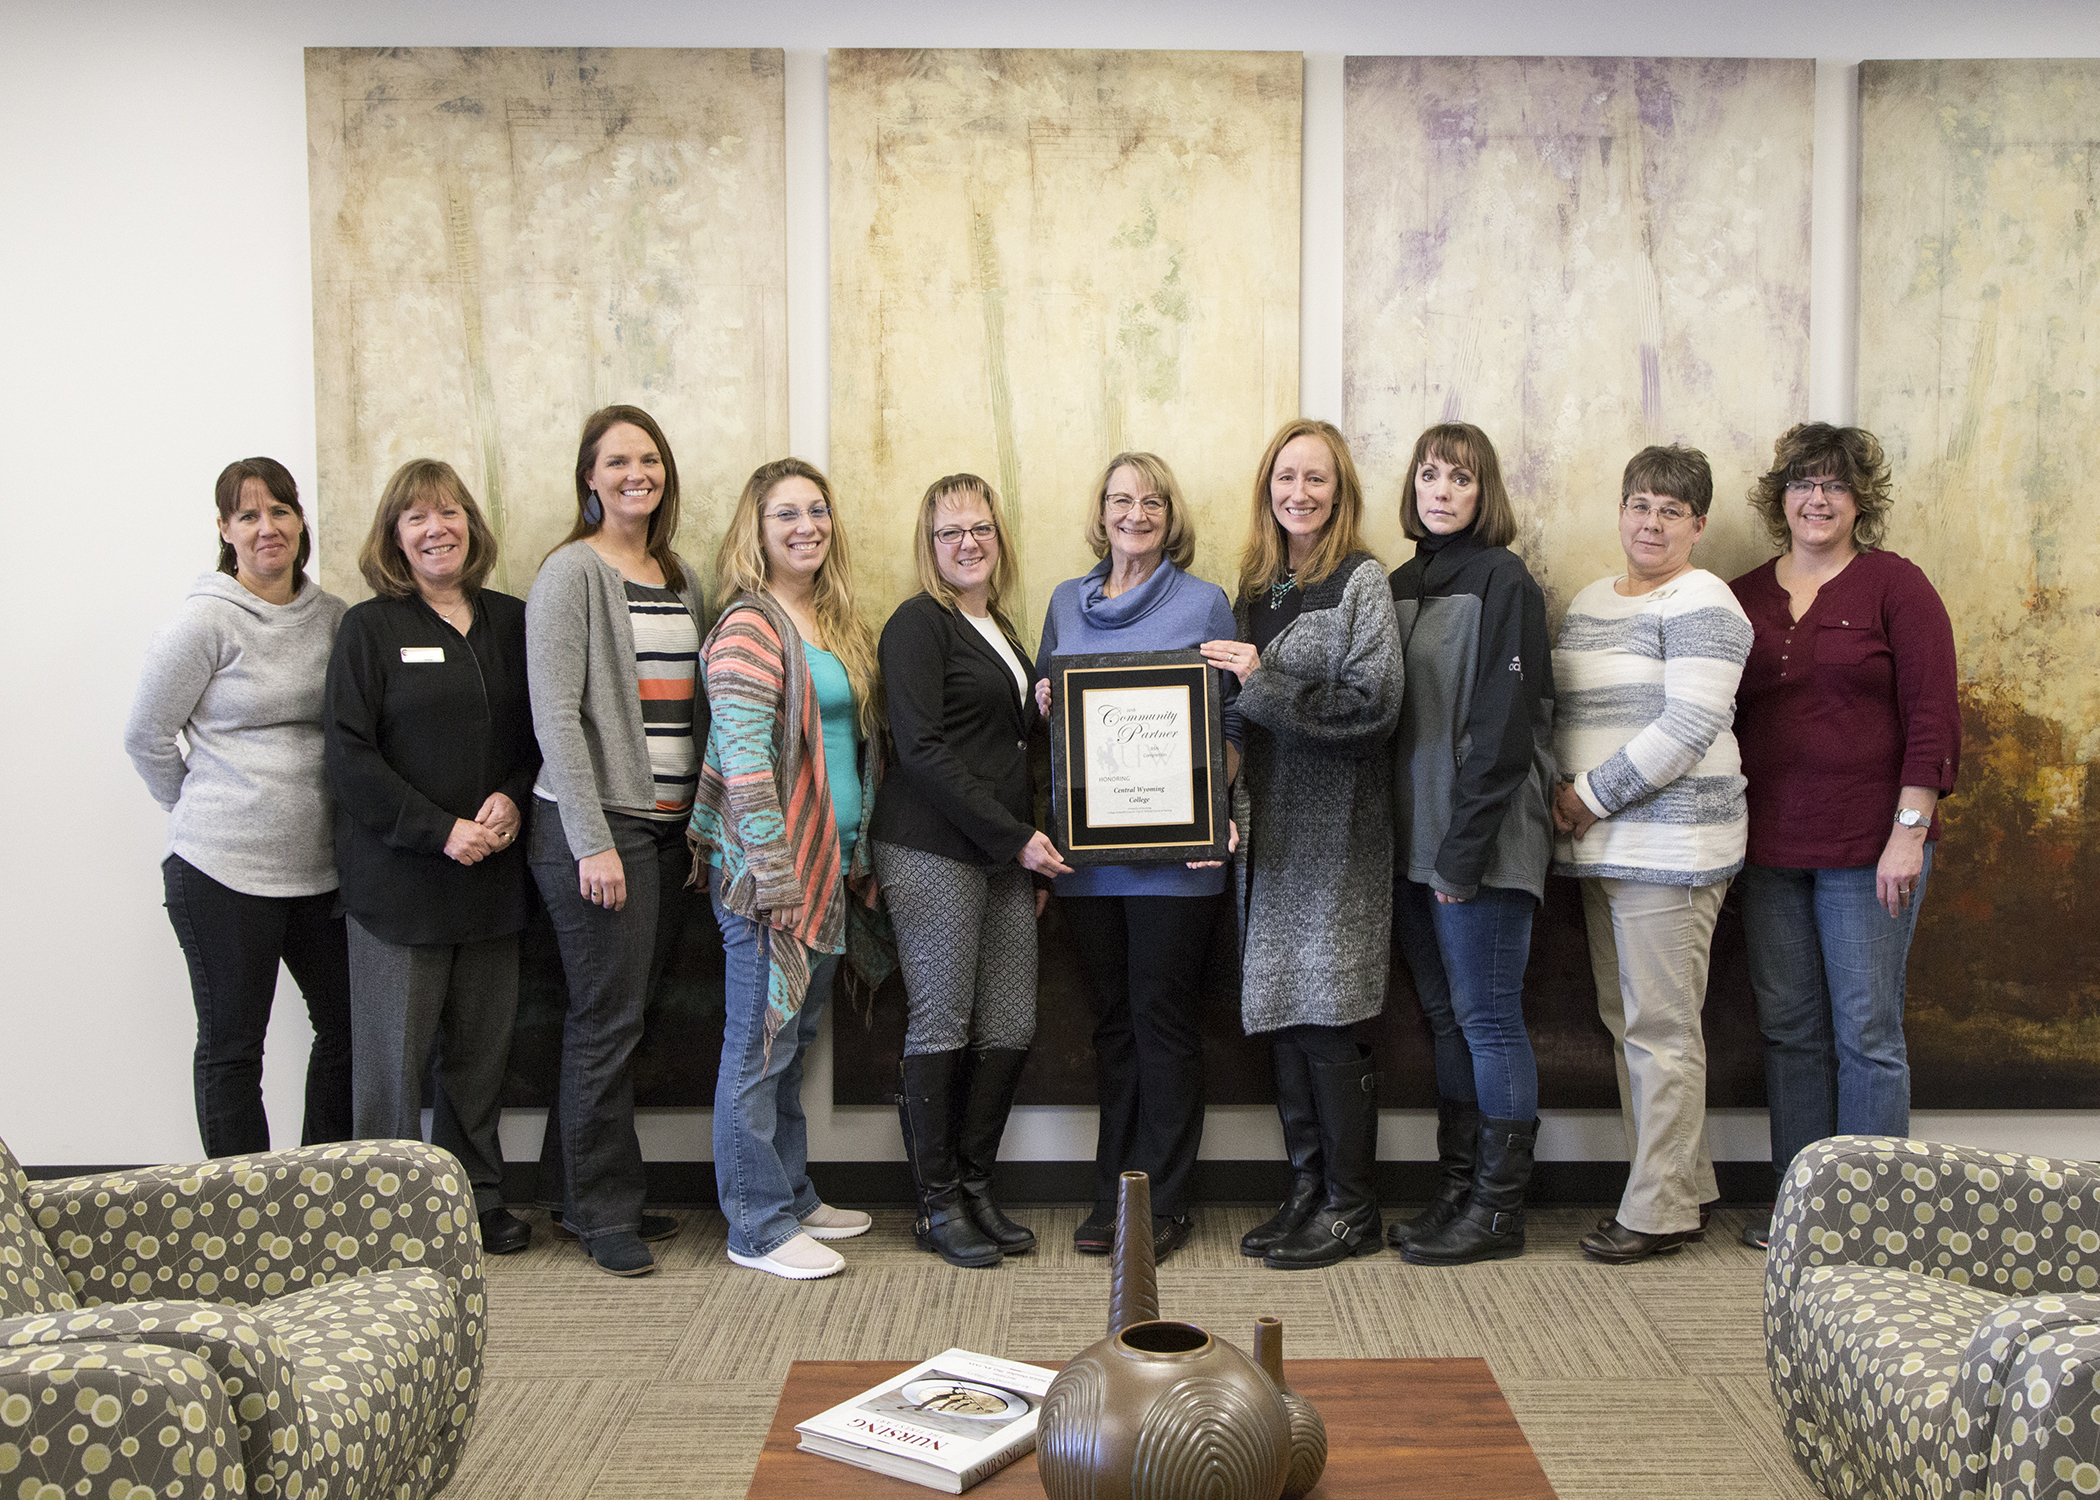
[1859,61,2100,1107]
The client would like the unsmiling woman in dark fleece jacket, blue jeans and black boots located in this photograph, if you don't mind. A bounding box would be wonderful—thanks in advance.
[1386,422,1554,1265]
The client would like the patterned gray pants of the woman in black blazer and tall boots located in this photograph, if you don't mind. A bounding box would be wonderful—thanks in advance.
[874,842,1035,1057]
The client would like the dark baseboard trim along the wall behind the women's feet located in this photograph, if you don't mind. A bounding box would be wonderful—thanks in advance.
[23,1162,1779,1208]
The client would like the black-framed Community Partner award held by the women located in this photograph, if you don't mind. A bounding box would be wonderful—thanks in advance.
[1050,651,1231,866]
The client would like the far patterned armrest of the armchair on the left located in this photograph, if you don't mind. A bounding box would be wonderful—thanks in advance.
[29,1141,481,1310]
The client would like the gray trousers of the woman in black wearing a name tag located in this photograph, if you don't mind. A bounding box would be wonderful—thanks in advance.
[349,916,519,1214]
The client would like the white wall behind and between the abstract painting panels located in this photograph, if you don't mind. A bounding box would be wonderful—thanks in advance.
[0,0,2100,1164]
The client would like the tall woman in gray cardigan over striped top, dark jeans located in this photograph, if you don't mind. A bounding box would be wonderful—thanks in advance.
[525,405,708,1275]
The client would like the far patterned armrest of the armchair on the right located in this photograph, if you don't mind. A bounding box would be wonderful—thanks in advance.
[1766,1137,2100,1305]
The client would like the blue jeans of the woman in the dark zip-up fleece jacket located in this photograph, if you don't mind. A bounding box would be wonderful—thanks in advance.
[1392,880,1539,1122]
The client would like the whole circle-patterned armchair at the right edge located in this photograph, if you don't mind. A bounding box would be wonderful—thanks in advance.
[1764,1137,2100,1500]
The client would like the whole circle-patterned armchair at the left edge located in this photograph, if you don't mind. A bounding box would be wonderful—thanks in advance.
[0,1141,485,1500]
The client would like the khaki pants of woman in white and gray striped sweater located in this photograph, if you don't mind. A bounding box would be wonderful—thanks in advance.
[1581,880,1728,1235]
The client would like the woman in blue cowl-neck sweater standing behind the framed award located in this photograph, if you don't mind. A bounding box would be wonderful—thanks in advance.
[1035,454,1239,1256]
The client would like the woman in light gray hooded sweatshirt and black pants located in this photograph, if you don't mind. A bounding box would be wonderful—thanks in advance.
[124,458,351,1155]
